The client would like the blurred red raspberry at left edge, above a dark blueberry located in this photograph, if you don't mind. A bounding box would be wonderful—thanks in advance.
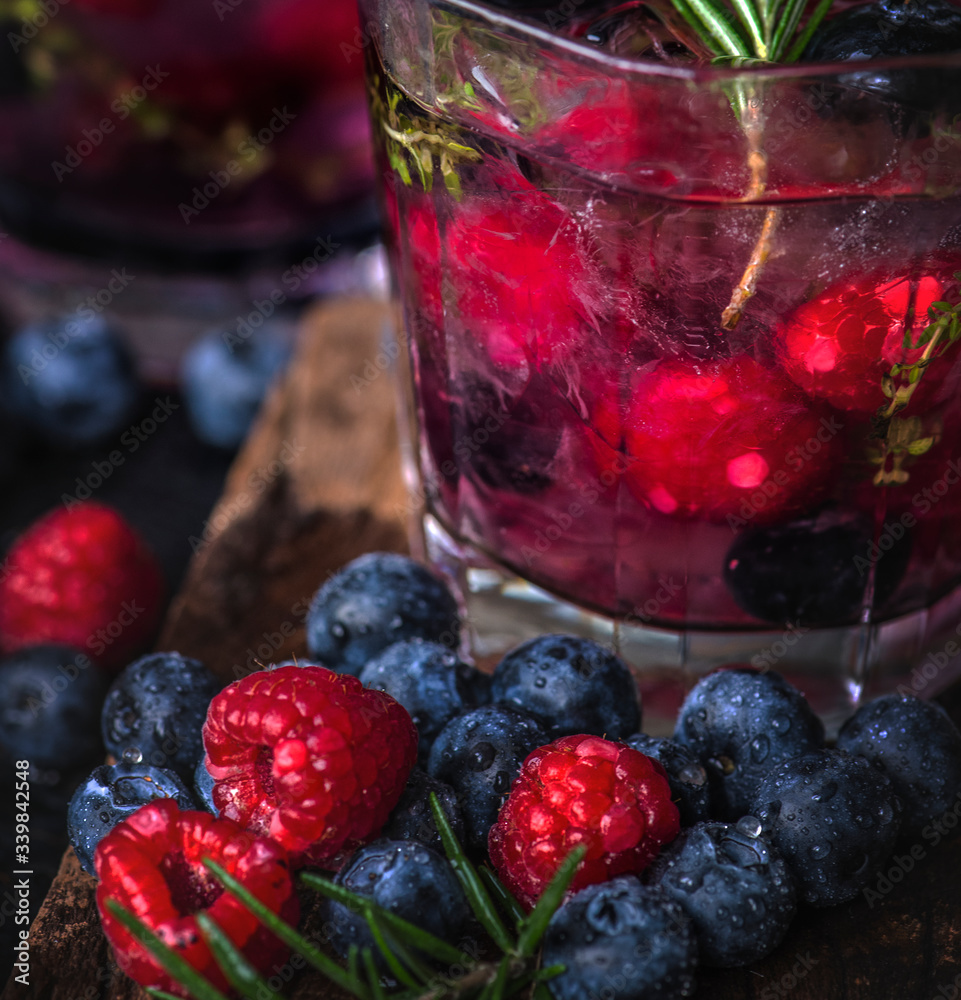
[0,502,164,669]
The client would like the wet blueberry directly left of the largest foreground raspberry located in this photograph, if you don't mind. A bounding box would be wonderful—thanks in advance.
[101,653,221,781]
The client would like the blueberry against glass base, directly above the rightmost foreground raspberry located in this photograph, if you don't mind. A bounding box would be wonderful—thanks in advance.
[491,635,641,740]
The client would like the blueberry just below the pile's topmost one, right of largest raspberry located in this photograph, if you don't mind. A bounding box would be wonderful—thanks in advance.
[360,639,473,764]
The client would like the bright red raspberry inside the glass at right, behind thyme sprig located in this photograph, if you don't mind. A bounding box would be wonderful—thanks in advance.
[778,274,957,413]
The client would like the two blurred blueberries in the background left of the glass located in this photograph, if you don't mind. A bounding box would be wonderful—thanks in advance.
[0,309,290,454]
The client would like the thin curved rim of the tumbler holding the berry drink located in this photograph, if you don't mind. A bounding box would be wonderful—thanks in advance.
[428,0,961,83]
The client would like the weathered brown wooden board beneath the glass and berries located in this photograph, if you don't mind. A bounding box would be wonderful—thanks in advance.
[7,301,961,1000]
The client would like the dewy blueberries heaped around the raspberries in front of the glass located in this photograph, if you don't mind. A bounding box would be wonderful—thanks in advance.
[7,553,961,1000]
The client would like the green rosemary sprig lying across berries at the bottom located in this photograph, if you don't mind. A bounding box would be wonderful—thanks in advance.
[107,795,584,1000]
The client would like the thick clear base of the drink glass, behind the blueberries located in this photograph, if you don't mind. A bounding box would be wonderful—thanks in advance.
[419,514,961,737]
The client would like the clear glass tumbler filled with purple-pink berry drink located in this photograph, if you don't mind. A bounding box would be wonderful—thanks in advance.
[361,0,961,728]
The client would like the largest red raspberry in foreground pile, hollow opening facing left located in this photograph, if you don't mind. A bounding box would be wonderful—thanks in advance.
[203,665,417,868]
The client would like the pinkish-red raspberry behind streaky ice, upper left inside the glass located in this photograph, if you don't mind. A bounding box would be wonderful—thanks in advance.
[446,175,597,371]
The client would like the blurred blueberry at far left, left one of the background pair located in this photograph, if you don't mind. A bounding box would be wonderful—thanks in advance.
[0,316,140,448]
